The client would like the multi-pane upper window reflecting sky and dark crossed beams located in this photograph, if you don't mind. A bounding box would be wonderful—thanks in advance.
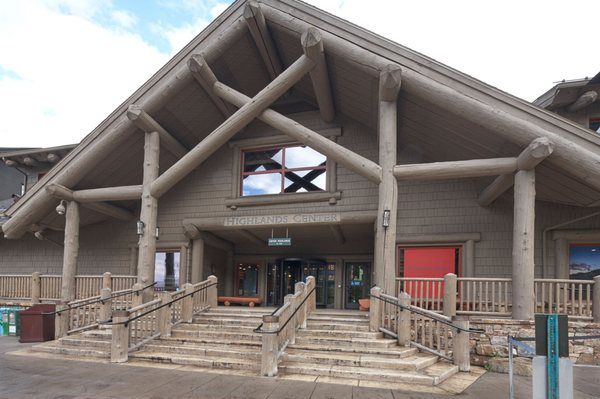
[241,145,327,196]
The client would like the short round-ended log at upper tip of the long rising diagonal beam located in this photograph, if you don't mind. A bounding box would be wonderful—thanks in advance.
[300,27,335,122]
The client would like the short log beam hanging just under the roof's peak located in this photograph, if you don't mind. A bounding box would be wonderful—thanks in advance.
[244,1,283,79]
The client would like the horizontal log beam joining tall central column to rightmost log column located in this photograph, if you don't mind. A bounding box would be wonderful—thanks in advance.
[394,158,517,180]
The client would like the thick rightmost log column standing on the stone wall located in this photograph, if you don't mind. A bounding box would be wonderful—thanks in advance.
[512,169,535,320]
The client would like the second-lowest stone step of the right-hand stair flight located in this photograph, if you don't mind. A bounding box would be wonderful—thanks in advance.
[283,349,438,371]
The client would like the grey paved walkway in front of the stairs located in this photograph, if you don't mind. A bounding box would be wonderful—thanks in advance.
[0,337,600,399]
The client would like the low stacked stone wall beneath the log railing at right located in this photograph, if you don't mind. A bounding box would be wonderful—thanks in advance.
[471,318,600,375]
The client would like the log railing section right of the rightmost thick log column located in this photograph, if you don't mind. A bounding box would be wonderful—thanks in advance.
[534,279,594,319]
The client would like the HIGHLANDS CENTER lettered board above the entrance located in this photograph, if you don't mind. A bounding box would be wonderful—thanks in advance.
[223,213,341,227]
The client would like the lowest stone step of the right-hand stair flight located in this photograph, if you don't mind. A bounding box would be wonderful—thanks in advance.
[279,362,458,385]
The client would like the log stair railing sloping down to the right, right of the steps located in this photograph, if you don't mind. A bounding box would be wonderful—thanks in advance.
[369,287,483,371]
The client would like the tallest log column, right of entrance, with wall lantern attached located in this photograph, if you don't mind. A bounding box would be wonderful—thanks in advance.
[373,65,401,294]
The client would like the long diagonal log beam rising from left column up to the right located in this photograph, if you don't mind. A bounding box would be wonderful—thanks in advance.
[151,55,314,198]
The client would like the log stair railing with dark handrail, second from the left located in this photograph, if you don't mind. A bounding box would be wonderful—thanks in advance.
[104,276,218,363]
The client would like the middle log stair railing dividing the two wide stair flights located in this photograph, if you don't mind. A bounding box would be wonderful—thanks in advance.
[254,276,317,377]
